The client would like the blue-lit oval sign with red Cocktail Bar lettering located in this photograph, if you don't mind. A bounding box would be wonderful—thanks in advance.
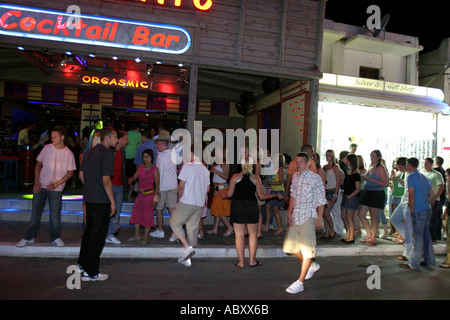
[0,4,191,54]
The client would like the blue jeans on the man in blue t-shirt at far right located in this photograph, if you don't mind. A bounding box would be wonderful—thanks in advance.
[408,209,436,270]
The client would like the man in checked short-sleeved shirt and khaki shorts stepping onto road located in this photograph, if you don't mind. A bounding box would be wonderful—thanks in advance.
[283,152,327,294]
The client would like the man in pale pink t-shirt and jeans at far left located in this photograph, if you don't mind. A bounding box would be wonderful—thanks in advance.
[16,126,76,247]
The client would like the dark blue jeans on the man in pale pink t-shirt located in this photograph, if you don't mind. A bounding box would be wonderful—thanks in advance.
[24,188,62,242]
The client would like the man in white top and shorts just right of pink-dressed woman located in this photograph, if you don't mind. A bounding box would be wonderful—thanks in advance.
[150,130,178,241]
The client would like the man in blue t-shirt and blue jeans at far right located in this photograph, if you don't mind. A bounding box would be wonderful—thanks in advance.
[400,158,436,270]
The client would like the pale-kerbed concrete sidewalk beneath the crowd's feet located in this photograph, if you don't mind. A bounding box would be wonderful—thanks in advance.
[0,221,446,259]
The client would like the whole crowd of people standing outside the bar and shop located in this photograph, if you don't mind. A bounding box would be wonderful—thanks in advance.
[8,123,450,293]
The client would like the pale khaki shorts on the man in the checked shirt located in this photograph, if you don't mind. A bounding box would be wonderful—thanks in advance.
[283,218,316,258]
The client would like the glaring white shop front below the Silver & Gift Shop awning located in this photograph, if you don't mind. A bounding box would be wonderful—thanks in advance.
[318,102,438,170]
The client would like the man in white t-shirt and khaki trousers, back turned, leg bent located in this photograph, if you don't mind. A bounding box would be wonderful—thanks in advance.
[170,152,210,266]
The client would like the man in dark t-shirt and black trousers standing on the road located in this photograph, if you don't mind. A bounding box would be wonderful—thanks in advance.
[78,128,118,281]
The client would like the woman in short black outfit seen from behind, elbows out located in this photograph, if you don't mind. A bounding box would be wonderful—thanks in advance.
[221,158,283,268]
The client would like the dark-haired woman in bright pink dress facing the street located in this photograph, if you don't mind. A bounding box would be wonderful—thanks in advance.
[128,149,159,245]
